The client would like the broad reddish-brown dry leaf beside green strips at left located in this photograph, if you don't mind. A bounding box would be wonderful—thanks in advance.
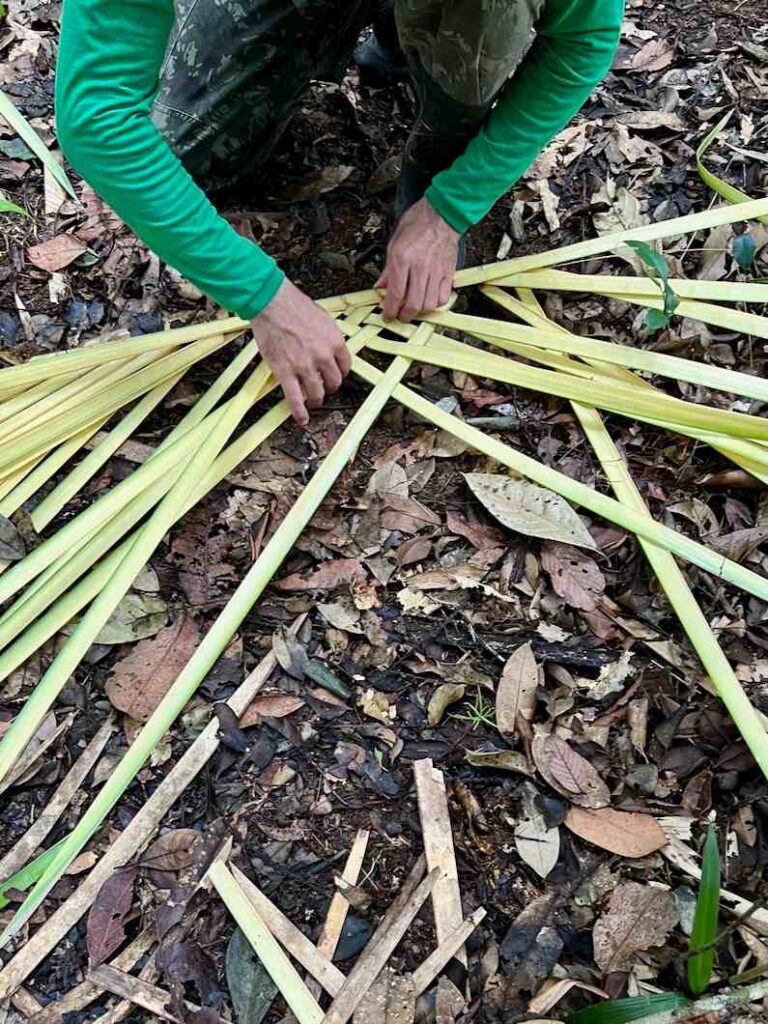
[104,615,200,722]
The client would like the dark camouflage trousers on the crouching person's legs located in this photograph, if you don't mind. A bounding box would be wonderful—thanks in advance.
[153,0,543,191]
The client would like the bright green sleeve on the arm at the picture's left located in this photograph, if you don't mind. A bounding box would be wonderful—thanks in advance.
[56,0,283,319]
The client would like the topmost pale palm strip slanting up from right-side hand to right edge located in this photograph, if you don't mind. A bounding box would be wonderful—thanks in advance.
[454,199,768,288]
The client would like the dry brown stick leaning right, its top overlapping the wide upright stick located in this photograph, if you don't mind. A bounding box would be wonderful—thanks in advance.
[323,865,440,1024]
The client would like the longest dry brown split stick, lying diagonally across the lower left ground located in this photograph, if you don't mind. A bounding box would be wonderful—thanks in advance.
[0,630,294,999]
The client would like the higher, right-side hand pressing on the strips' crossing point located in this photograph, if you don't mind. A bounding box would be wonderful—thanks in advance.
[376,199,460,324]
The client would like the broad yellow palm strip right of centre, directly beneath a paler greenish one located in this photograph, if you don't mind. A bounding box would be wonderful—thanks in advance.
[370,338,768,438]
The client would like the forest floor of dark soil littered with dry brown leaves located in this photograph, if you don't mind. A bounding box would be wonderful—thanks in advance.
[0,0,768,1024]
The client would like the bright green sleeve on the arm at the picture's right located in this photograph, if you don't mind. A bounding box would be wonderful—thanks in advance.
[427,0,624,231]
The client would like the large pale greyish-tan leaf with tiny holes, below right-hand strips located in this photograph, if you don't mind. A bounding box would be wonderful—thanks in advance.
[464,473,595,549]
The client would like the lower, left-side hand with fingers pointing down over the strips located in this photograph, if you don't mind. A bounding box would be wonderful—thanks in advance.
[251,279,351,427]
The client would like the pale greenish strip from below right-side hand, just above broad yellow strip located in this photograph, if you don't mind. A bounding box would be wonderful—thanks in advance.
[422,310,768,401]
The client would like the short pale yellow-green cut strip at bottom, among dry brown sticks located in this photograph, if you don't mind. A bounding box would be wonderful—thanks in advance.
[208,860,323,1024]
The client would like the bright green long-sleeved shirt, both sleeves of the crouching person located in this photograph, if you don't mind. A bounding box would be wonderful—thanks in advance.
[56,0,623,318]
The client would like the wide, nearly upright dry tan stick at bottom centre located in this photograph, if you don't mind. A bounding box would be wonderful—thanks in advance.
[414,758,467,967]
